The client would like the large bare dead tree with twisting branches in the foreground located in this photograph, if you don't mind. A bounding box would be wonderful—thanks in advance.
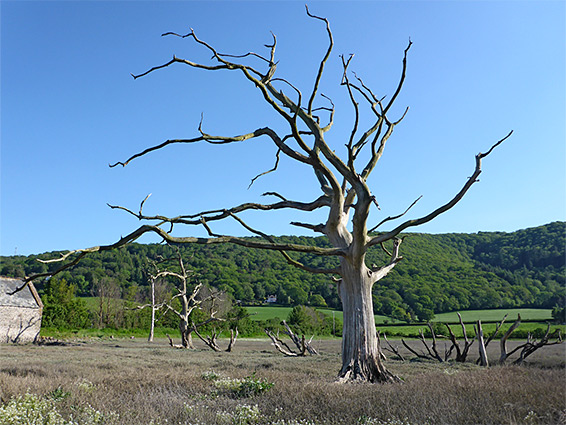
[21,8,511,382]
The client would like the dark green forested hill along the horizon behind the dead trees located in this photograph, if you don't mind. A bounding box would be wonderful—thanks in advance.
[0,222,566,319]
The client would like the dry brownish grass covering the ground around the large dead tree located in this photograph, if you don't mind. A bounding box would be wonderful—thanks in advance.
[0,340,566,425]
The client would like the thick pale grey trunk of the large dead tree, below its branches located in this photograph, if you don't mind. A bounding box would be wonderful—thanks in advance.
[338,269,399,382]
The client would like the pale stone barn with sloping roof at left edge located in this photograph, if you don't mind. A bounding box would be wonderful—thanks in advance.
[0,276,43,343]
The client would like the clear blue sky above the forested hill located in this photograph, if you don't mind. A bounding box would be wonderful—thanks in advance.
[0,1,566,255]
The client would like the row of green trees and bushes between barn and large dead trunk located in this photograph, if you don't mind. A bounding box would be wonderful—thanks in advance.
[40,277,342,336]
